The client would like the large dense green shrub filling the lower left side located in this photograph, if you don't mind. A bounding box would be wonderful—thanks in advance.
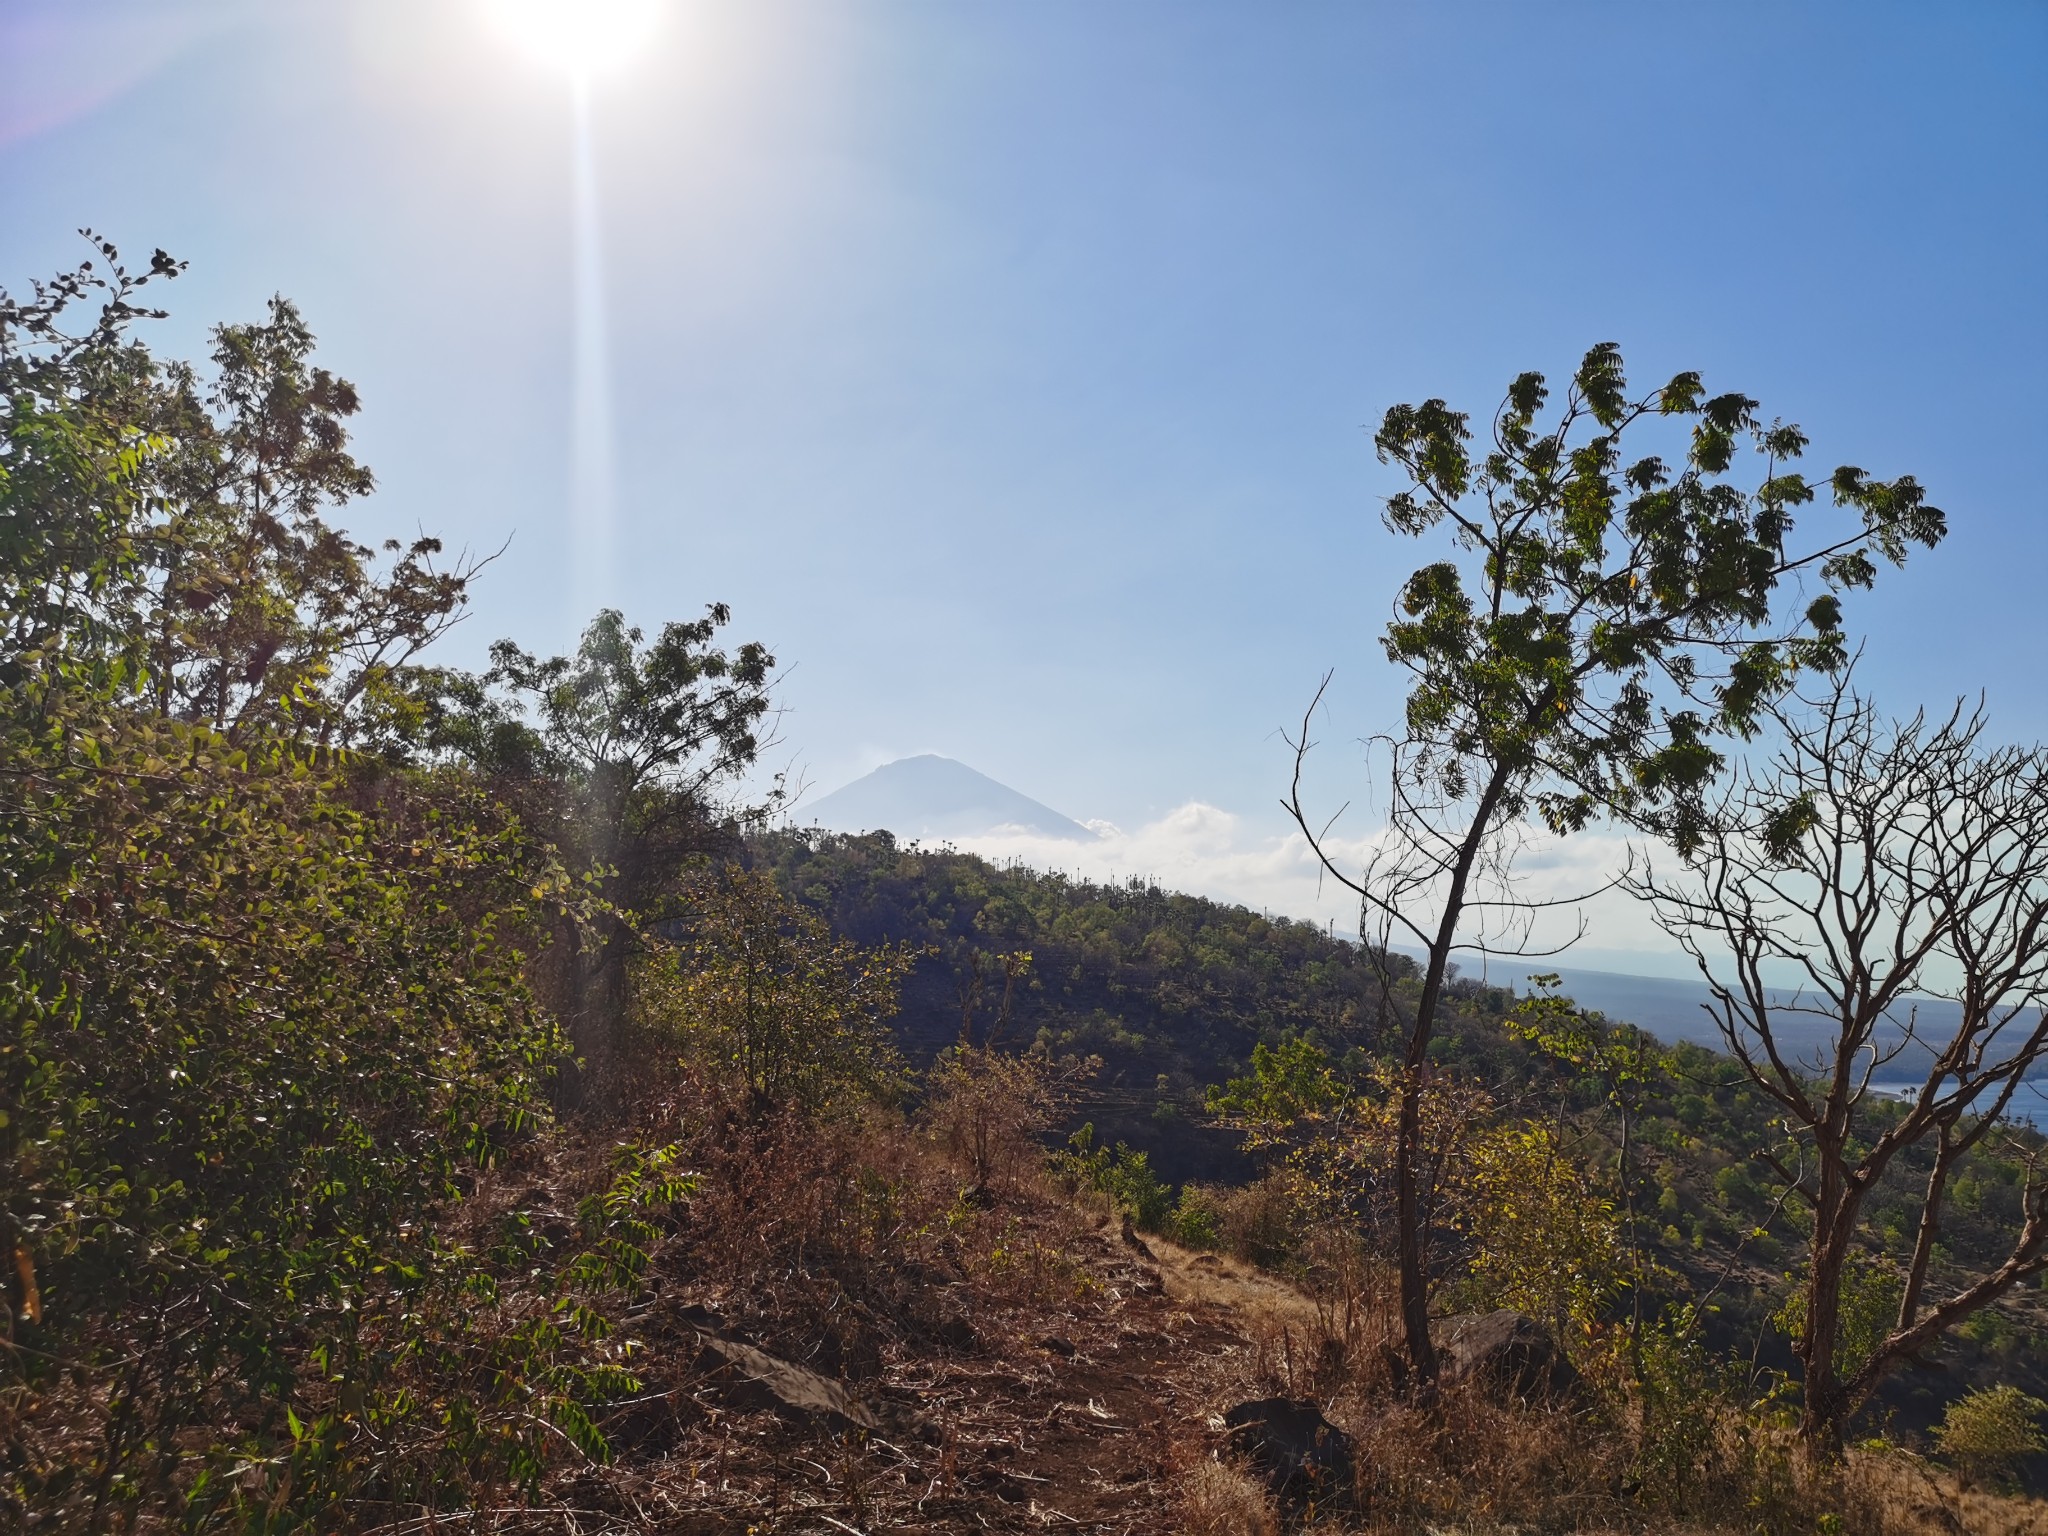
[0,692,598,1524]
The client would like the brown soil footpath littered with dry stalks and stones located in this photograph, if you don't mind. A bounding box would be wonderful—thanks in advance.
[548,1210,1277,1536]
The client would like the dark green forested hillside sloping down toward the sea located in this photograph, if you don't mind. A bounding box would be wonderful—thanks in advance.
[754,831,2048,1430]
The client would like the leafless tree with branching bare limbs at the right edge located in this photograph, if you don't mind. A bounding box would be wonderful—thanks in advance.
[1632,674,2048,1452]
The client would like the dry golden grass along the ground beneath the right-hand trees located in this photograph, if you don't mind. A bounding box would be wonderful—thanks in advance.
[1147,1239,2048,1536]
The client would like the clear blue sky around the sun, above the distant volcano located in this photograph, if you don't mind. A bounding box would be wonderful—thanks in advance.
[0,0,2048,962]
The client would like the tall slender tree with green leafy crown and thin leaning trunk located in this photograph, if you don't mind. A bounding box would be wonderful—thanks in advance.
[1288,344,1946,1384]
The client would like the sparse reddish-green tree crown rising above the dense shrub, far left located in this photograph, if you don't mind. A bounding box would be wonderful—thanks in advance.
[0,242,483,745]
